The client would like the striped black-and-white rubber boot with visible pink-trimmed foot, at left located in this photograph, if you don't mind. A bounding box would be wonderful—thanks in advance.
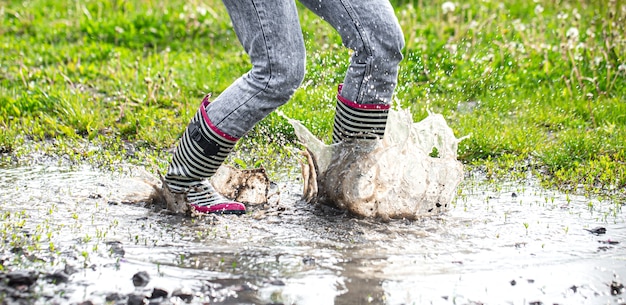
[164,95,246,214]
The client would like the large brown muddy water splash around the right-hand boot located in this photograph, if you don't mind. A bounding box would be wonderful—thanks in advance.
[281,110,463,219]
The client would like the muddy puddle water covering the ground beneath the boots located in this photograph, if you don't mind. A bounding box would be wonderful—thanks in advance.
[0,165,626,304]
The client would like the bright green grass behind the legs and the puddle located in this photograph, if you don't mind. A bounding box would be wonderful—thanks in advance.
[0,0,626,197]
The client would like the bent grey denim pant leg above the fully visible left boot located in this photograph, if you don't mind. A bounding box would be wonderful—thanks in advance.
[206,0,305,138]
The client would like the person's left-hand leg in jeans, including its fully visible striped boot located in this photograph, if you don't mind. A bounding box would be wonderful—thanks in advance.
[165,0,305,213]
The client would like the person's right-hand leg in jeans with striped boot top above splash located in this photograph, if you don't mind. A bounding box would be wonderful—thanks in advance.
[300,0,404,143]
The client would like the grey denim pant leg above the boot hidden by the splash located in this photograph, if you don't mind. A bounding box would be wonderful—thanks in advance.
[300,0,404,104]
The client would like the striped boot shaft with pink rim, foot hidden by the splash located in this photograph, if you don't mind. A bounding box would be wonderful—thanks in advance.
[333,85,390,143]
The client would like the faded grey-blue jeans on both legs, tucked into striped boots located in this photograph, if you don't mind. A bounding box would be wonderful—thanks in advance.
[206,0,404,138]
